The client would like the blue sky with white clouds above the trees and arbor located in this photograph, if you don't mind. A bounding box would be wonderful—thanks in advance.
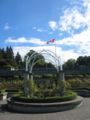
[0,0,90,61]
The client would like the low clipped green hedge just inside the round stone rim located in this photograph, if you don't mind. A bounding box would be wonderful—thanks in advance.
[11,91,77,103]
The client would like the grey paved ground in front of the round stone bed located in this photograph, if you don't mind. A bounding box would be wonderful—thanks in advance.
[0,98,90,120]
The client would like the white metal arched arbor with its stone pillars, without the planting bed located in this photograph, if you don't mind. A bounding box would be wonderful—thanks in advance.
[24,50,64,96]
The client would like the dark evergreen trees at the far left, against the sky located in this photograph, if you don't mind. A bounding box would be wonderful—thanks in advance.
[0,46,22,69]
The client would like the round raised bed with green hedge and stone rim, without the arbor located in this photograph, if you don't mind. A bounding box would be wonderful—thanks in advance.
[7,91,82,113]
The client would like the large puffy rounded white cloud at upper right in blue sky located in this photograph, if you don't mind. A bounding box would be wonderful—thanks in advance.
[59,9,87,32]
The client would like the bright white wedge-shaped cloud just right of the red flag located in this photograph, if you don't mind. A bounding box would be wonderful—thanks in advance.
[57,29,90,47]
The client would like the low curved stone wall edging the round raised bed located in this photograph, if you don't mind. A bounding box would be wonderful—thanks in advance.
[7,96,83,113]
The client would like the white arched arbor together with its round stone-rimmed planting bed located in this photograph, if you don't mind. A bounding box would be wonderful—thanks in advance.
[8,50,82,113]
